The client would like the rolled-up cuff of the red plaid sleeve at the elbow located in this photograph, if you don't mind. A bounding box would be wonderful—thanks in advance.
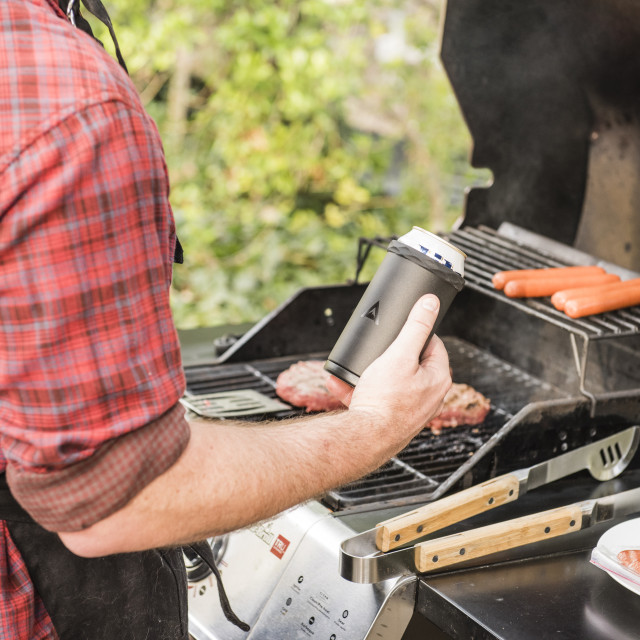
[7,402,191,531]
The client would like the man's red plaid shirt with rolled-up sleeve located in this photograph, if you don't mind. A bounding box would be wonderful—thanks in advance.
[0,0,189,640]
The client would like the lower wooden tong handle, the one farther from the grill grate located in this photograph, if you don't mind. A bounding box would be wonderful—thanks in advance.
[415,505,582,573]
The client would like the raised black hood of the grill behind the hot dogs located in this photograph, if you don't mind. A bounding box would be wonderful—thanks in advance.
[441,0,640,270]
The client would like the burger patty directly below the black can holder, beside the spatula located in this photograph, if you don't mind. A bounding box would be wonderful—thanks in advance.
[276,360,344,411]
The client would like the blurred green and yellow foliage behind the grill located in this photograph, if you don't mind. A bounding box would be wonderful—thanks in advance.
[87,0,478,327]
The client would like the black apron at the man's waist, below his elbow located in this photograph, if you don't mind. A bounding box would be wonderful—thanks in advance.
[0,473,189,640]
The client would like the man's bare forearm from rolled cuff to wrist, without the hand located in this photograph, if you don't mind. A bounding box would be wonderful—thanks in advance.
[60,411,396,557]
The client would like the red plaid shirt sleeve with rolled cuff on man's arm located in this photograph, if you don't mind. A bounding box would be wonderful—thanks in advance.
[0,99,189,531]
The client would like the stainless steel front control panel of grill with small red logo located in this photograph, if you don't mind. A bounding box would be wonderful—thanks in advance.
[189,502,417,640]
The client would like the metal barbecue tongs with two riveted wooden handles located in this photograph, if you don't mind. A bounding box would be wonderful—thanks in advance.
[340,426,640,583]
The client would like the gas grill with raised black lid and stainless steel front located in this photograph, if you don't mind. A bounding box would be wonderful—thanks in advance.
[183,0,640,640]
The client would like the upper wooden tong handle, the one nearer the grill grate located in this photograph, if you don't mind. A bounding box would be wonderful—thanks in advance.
[376,474,520,551]
